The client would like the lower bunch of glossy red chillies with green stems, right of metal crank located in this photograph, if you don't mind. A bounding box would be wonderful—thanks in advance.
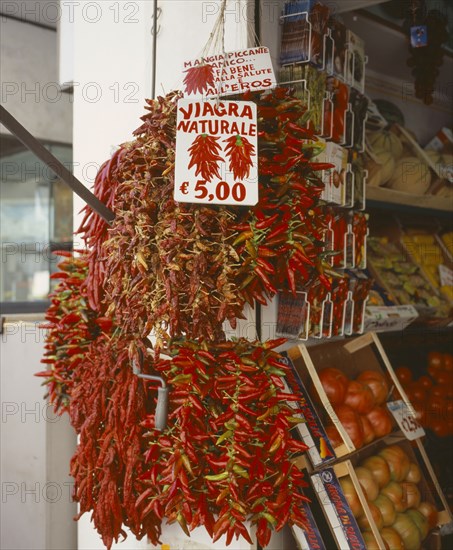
[137,339,307,546]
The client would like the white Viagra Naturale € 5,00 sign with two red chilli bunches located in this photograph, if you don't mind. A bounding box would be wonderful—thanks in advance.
[174,99,258,206]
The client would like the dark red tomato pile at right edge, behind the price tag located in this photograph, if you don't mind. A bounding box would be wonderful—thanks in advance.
[395,351,453,437]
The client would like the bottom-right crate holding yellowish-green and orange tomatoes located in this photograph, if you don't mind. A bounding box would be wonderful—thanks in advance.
[310,433,452,550]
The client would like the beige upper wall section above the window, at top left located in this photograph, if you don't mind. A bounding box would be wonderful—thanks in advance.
[0,16,72,143]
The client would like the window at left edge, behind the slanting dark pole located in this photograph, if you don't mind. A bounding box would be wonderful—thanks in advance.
[0,135,73,313]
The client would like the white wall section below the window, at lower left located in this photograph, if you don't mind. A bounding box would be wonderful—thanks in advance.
[0,323,77,550]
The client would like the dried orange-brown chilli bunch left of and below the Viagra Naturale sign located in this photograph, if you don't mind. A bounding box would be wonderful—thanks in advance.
[102,94,243,339]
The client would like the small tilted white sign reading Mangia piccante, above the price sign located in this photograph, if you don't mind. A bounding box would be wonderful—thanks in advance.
[183,47,277,97]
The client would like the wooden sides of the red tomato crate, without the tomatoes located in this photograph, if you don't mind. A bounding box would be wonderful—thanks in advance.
[287,332,413,467]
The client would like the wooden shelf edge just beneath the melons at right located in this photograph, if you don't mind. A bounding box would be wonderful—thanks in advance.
[366,187,453,217]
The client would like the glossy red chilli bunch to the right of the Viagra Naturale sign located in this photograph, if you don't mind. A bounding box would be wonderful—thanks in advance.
[231,88,338,304]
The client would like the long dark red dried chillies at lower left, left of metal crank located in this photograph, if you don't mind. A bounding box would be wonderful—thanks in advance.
[69,335,160,548]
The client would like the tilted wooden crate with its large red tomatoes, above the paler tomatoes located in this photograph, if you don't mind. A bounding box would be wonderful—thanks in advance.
[286,332,413,468]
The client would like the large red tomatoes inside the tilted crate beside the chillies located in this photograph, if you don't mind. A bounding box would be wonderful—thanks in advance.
[312,367,393,449]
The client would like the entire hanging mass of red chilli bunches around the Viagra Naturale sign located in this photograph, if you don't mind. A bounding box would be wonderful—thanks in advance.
[40,89,346,548]
